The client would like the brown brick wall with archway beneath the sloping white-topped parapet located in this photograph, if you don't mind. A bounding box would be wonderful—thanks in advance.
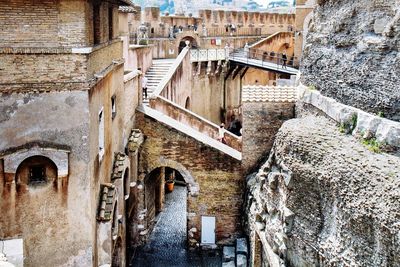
[136,113,245,246]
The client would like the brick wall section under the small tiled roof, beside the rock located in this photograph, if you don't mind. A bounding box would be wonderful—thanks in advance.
[242,102,294,175]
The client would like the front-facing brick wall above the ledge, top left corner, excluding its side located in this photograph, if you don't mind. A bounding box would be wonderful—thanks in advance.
[0,0,91,47]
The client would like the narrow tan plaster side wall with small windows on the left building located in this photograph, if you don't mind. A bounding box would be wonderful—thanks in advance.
[89,65,138,263]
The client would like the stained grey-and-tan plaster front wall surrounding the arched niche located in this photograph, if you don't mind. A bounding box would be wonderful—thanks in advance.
[0,91,94,266]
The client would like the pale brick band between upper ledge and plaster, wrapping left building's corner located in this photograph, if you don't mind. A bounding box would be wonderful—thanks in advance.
[0,41,122,92]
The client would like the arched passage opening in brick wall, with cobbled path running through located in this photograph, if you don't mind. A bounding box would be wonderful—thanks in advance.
[132,167,190,266]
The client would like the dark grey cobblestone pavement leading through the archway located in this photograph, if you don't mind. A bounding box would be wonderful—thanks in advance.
[129,185,222,267]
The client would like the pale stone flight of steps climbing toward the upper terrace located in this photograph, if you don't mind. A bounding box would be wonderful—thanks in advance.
[143,59,175,105]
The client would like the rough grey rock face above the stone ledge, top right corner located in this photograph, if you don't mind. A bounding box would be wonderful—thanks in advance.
[302,0,400,121]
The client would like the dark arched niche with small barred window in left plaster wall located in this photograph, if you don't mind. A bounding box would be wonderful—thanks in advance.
[15,156,58,186]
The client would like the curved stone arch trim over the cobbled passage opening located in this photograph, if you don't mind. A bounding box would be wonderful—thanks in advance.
[147,157,200,196]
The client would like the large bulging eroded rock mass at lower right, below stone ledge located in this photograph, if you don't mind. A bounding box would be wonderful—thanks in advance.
[246,113,400,266]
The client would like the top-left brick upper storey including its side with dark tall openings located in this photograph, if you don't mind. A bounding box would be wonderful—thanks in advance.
[0,0,119,47]
